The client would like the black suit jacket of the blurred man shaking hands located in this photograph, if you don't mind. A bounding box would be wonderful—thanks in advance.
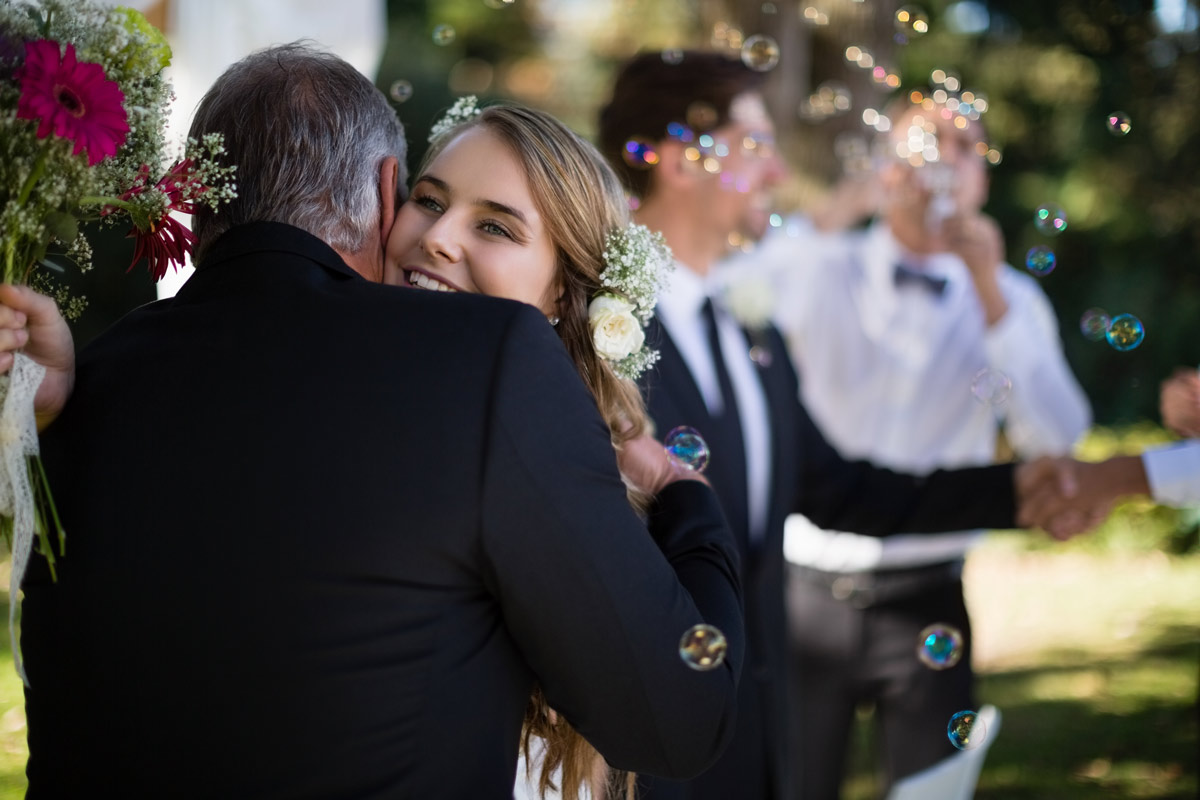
[642,320,1014,800]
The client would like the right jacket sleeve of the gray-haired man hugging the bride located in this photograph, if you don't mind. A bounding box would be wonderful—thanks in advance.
[481,303,744,778]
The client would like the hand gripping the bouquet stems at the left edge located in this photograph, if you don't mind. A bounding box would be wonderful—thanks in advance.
[0,283,74,431]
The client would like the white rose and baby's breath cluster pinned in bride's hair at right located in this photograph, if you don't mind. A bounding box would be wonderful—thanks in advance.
[588,223,674,380]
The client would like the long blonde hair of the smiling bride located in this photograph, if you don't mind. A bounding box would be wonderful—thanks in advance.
[416,106,650,800]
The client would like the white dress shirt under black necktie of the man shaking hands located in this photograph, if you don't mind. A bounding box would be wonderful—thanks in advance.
[656,263,772,541]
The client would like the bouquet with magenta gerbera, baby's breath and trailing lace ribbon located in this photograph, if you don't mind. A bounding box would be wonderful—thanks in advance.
[0,0,236,676]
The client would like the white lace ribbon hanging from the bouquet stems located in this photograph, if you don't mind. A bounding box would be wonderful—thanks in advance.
[0,353,46,686]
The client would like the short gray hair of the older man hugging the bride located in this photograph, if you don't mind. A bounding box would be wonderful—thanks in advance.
[190,42,408,260]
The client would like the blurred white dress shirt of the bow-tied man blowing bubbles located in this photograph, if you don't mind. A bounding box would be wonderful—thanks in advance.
[722,221,1091,571]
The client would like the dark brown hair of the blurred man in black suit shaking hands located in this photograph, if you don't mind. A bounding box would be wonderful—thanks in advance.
[598,50,763,197]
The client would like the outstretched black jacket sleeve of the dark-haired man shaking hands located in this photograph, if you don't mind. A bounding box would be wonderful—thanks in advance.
[792,386,1016,536]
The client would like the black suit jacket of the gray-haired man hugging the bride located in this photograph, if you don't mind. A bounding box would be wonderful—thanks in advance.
[22,223,743,800]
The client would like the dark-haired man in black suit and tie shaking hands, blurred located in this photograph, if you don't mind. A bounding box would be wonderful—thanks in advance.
[599,52,1025,800]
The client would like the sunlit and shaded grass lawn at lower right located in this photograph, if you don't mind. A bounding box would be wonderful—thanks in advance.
[846,534,1200,800]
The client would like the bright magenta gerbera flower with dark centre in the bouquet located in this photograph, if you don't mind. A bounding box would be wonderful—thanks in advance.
[17,38,130,167]
